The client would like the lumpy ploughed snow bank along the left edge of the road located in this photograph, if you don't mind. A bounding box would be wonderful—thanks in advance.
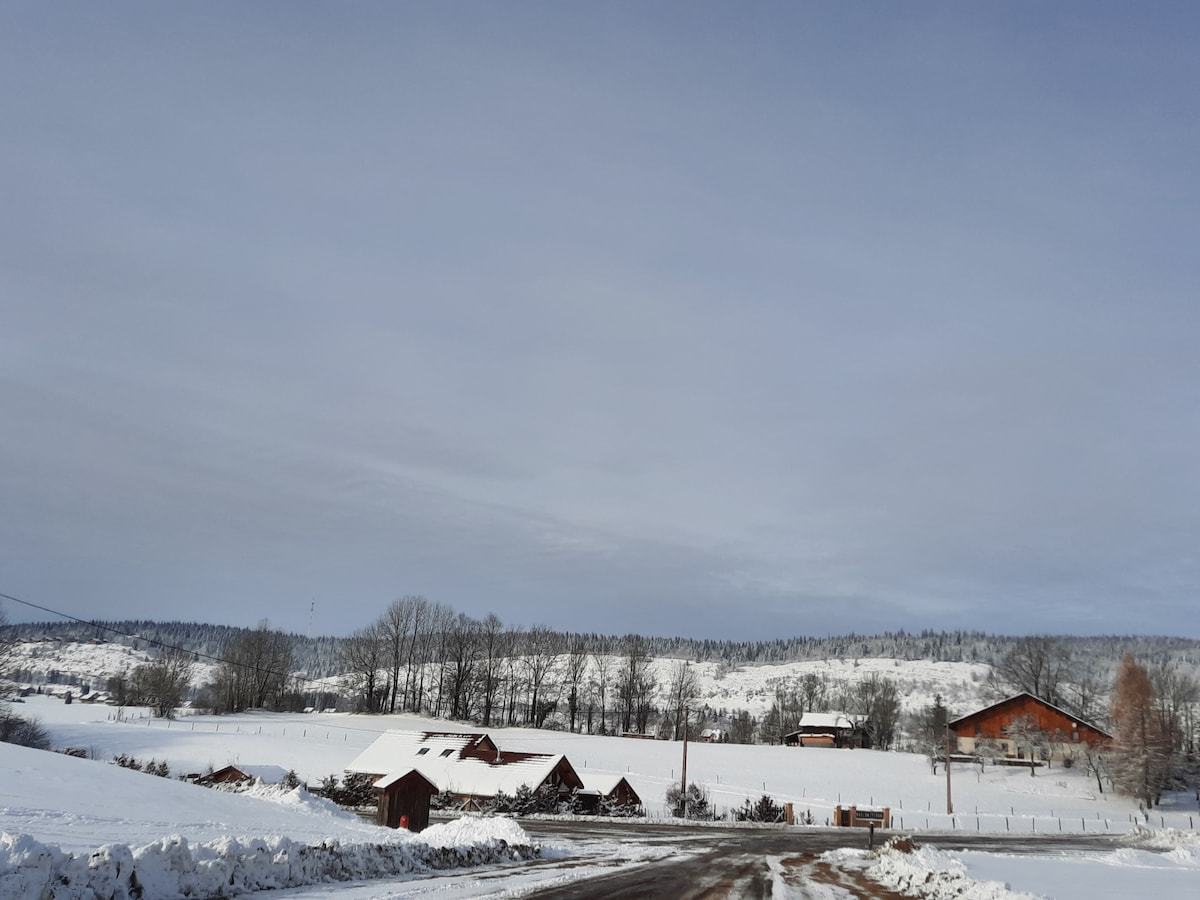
[0,818,541,900]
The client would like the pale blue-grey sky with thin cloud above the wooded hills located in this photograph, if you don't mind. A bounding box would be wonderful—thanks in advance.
[0,2,1200,640]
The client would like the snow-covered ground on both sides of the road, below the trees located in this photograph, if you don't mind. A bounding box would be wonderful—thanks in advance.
[7,676,1200,900]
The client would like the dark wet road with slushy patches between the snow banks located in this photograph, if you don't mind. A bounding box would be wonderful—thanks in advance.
[522,820,1121,900]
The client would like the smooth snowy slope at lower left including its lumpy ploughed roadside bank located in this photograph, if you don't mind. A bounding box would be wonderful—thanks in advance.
[0,744,541,900]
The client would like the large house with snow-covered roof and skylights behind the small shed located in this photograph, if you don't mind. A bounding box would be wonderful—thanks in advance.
[346,730,583,809]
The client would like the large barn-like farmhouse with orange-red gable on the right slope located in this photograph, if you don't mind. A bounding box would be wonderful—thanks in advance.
[948,692,1112,761]
